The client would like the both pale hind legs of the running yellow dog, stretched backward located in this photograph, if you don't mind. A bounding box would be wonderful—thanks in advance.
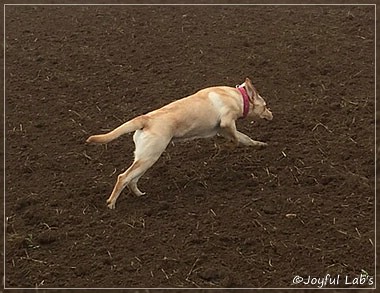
[107,130,170,209]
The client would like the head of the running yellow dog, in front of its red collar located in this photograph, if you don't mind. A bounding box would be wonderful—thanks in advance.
[242,77,273,120]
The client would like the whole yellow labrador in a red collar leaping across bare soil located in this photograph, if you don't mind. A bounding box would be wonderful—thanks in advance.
[87,78,273,209]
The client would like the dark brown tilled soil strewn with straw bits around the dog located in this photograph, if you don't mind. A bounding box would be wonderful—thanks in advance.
[5,6,375,288]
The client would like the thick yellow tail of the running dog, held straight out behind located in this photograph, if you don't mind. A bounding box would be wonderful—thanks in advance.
[86,116,146,143]
